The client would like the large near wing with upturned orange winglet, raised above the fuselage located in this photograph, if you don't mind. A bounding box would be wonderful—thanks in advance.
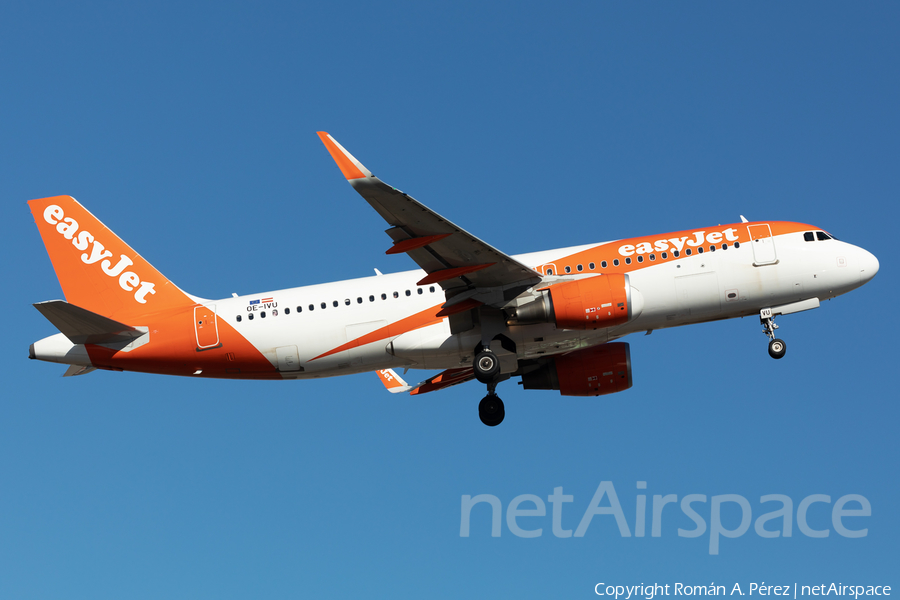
[319,131,541,304]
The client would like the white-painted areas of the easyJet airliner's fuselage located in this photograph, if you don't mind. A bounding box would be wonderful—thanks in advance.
[205,233,878,378]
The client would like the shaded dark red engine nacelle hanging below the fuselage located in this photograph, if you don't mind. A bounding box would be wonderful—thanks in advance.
[522,342,631,396]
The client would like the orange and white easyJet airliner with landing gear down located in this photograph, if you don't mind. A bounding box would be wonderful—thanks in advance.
[28,132,879,427]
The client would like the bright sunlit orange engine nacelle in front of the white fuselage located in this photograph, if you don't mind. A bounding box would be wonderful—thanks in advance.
[515,273,644,329]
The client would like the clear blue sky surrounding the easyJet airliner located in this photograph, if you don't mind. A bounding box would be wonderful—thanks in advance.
[0,2,900,599]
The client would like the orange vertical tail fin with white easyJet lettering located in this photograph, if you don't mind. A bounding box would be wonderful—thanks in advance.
[28,196,194,323]
